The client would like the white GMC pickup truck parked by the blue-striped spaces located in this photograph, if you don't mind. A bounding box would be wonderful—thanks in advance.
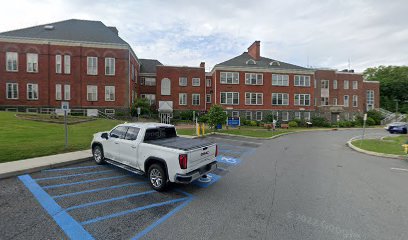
[91,123,218,191]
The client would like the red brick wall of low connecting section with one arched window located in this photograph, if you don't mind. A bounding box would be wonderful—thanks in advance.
[156,66,205,111]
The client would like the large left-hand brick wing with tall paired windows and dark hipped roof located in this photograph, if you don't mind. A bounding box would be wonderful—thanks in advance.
[0,19,140,113]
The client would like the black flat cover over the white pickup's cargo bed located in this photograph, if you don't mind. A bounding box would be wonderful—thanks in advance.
[145,137,214,151]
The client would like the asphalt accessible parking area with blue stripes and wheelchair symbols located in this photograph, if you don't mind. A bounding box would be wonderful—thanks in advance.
[0,136,262,239]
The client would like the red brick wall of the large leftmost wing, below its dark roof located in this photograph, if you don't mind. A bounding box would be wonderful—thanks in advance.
[0,42,131,108]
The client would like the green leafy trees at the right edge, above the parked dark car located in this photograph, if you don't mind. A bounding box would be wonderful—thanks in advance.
[364,66,408,113]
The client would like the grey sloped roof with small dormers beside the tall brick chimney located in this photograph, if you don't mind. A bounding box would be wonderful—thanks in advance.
[215,52,309,70]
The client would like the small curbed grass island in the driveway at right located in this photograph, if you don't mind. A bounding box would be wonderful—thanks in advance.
[353,136,408,155]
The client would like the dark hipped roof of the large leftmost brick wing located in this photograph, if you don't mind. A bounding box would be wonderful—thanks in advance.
[0,19,128,45]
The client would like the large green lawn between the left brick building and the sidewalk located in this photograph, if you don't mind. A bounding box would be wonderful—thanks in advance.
[0,112,123,163]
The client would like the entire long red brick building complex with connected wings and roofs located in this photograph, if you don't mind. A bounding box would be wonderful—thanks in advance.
[0,20,379,122]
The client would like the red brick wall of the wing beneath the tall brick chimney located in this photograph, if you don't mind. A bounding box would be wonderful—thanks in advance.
[214,70,314,110]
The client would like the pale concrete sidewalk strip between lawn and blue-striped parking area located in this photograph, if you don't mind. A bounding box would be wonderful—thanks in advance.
[0,149,92,179]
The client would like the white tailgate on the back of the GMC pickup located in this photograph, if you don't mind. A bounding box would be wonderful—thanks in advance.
[187,144,216,170]
